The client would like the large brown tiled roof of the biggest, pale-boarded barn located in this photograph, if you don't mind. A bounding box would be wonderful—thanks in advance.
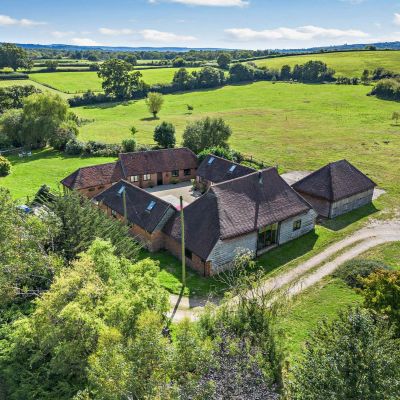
[165,168,311,260]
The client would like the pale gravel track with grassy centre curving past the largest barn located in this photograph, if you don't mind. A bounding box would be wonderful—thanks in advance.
[171,221,400,321]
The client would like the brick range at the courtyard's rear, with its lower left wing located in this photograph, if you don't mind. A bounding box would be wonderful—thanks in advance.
[61,147,197,198]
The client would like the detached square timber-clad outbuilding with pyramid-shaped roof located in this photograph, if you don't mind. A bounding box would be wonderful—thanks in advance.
[293,160,376,218]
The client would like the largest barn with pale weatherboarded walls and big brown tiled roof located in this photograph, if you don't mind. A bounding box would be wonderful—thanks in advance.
[163,168,317,276]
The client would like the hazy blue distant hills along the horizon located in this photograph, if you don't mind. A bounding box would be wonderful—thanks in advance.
[10,42,400,54]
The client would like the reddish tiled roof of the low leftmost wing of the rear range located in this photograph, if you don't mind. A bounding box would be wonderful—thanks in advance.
[61,162,122,189]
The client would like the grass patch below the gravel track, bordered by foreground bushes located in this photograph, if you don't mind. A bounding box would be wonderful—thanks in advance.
[278,277,362,362]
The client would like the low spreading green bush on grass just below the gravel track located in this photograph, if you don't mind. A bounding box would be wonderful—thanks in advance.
[333,260,388,288]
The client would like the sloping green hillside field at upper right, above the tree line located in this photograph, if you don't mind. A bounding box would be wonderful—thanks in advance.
[255,51,400,77]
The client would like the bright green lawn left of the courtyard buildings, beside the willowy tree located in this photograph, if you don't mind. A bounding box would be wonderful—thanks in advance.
[0,149,114,202]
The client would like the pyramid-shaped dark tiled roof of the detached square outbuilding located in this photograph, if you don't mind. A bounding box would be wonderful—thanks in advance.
[293,160,376,201]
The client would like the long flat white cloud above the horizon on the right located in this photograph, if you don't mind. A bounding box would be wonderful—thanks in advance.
[225,25,369,42]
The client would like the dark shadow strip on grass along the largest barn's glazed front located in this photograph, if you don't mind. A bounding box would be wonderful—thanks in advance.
[257,231,319,274]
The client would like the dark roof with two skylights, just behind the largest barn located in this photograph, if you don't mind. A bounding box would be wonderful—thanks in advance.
[197,154,255,183]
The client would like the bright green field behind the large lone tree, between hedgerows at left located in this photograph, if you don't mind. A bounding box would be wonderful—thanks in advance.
[29,68,200,93]
